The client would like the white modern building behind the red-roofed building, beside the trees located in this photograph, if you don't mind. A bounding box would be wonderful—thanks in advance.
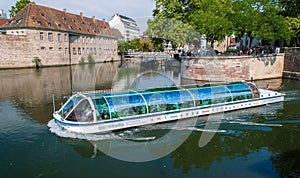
[109,14,140,40]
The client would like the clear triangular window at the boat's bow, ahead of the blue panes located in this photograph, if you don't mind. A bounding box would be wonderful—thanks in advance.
[66,99,93,122]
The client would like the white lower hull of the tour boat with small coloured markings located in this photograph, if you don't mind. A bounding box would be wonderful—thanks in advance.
[54,94,284,134]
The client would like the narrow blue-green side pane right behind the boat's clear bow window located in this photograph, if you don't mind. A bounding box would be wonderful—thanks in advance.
[93,97,110,120]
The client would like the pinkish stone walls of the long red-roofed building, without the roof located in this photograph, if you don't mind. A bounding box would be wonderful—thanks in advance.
[0,29,119,68]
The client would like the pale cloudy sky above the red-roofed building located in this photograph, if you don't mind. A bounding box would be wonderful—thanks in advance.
[0,0,155,31]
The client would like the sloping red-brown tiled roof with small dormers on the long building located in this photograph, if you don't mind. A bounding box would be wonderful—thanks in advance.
[1,3,112,35]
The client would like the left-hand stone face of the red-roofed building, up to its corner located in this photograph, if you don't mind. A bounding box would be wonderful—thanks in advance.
[0,29,69,68]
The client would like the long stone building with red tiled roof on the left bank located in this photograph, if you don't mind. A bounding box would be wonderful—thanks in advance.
[0,3,118,68]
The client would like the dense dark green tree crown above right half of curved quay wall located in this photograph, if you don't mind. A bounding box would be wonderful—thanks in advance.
[230,0,291,44]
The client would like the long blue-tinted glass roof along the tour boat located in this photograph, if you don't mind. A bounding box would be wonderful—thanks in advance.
[78,82,253,118]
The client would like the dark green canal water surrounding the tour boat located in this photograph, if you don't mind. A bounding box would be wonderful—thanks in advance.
[0,61,300,178]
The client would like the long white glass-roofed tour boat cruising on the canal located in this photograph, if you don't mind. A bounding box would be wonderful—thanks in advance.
[53,81,284,133]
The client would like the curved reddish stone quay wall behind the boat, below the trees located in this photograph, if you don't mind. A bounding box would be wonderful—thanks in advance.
[182,54,284,81]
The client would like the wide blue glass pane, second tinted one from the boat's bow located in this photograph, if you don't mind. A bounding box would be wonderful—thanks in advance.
[106,94,147,118]
